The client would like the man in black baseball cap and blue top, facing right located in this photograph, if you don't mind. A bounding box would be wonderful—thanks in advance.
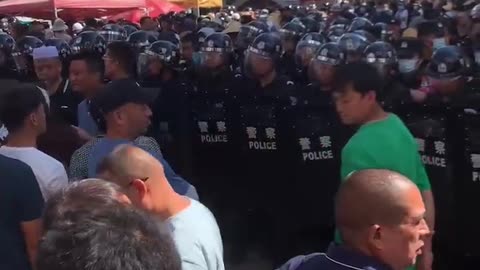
[70,80,198,199]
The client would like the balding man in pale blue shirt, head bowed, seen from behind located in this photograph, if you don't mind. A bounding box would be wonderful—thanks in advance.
[97,145,225,270]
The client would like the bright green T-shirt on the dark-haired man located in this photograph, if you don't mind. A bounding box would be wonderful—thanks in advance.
[335,113,431,270]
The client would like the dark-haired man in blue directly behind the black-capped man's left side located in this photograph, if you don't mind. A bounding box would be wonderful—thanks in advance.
[69,52,104,136]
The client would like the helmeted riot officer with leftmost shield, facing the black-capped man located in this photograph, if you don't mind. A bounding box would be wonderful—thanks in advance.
[143,40,192,174]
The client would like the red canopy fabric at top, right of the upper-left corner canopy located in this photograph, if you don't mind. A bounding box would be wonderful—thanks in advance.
[108,0,184,22]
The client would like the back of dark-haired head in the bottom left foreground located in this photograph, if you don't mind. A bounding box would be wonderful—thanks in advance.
[36,179,181,270]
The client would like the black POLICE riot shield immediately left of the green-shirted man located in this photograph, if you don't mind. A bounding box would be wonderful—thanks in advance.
[287,103,344,254]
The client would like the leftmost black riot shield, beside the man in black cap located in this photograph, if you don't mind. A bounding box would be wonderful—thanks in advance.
[150,84,192,178]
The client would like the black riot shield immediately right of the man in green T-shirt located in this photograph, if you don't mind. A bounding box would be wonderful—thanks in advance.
[400,105,458,264]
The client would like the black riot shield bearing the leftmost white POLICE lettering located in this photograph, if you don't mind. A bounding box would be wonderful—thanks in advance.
[190,91,239,204]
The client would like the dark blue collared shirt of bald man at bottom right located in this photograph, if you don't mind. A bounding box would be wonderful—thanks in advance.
[296,244,392,270]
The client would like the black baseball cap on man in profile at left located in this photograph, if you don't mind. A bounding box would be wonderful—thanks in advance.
[93,79,154,115]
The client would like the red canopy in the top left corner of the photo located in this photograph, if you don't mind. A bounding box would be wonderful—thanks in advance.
[0,0,146,19]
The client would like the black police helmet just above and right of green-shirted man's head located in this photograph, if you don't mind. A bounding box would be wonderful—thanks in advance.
[363,41,398,66]
